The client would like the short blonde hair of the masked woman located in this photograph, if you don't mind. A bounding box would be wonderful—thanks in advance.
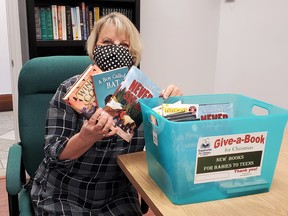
[86,12,142,66]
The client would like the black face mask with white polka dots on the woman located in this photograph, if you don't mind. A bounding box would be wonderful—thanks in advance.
[93,44,133,71]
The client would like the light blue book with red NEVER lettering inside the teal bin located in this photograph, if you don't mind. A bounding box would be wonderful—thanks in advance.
[198,103,233,120]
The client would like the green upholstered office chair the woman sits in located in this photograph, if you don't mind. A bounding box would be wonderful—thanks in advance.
[6,56,91,216]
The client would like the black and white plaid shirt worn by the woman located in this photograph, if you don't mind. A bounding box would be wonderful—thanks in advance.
[31,76,144,216]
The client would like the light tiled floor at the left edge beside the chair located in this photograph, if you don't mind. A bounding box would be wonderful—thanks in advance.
[0,111,15,177]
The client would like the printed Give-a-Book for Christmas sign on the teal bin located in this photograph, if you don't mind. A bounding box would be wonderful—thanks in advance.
[194,132,267,184]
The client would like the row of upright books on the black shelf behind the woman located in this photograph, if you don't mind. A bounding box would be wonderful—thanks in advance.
[34,2,133,40]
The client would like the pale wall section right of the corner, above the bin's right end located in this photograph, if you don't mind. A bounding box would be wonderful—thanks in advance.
[215,0,288,109]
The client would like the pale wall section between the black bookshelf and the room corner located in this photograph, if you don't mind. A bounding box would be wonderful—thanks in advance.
[140,0,220,94]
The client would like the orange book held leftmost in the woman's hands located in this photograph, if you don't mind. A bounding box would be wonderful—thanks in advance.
[63,65,102,119]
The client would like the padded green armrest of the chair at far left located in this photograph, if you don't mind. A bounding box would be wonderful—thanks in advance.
[6,143,23,195]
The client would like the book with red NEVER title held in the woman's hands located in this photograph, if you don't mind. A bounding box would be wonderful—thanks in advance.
[104,66,161,142]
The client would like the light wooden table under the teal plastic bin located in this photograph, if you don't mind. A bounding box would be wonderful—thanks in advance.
[118,132,288,216]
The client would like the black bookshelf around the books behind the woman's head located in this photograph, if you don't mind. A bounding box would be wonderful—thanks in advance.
[26,0,140,59]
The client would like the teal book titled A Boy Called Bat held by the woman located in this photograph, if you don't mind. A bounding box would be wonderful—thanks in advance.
[92,67,128,108]
